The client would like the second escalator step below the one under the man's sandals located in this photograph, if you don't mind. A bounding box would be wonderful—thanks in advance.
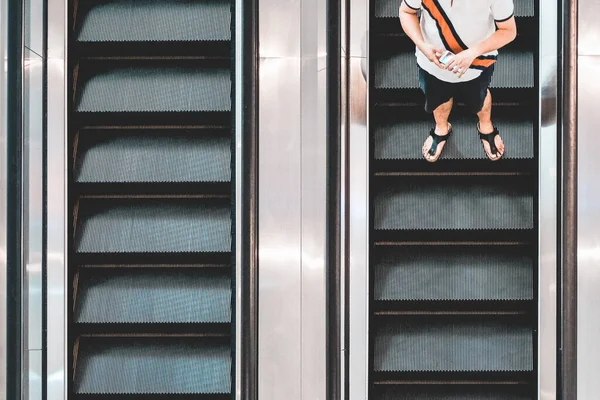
[374,246,534,301]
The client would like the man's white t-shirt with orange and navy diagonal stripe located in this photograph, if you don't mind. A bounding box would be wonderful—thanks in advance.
[403,0,514,83]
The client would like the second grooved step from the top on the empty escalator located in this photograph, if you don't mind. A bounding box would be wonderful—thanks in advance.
[76,67,231,112]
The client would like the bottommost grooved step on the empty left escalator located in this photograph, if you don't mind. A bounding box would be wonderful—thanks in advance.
[75,337,231,395]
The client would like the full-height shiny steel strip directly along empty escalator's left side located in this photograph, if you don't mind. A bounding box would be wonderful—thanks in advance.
[46,0,68,400]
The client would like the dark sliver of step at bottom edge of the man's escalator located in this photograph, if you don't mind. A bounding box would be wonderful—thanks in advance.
[375,385,533,400]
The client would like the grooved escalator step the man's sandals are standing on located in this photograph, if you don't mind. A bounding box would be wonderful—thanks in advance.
[373,117,534,160]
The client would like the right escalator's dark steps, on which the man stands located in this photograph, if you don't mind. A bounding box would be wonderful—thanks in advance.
[369,0,539,400]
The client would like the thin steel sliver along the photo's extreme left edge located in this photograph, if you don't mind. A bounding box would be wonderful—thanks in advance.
[0,0,10,400]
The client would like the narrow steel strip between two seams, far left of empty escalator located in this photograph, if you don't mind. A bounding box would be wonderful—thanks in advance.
[23,49,43,350]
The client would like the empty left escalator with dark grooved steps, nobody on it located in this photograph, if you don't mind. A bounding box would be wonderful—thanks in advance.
[68,0,237,399]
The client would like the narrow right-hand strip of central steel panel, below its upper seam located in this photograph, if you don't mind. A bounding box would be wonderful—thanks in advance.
[301,56,327,400]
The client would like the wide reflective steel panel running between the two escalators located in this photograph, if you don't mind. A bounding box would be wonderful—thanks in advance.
[258,0,326,400]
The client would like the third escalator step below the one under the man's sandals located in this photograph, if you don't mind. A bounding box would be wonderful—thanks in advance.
[374,320,533,372]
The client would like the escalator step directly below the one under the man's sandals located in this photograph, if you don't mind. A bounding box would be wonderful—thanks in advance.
[374,176,535,230]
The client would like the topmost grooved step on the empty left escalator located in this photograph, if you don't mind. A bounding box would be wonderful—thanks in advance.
[77,0,231,42]
